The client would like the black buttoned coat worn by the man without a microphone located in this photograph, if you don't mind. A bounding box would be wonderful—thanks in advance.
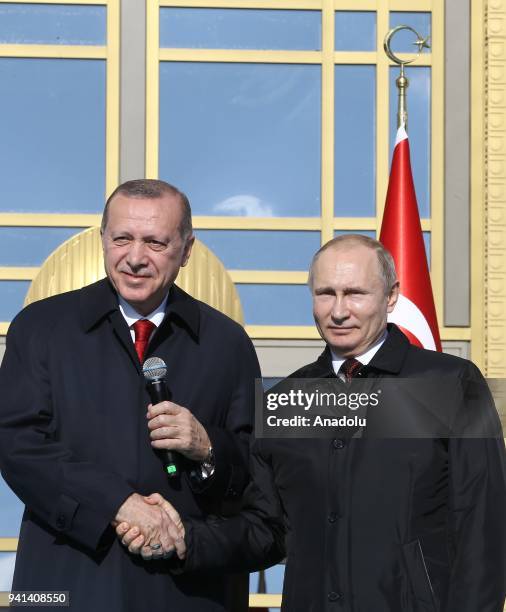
[182,325,506,612]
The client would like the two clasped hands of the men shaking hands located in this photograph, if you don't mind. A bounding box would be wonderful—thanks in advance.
[112,493,186,561]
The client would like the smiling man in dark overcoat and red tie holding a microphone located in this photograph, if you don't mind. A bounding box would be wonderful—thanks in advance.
[0,180,259,612]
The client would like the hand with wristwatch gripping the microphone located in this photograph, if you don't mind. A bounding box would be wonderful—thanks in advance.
[147,402,211,462]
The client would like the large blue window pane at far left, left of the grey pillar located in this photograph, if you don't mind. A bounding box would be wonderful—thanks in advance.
[0,58,106,213]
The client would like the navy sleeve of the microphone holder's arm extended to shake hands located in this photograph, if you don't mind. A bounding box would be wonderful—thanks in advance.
[0,313,133,550]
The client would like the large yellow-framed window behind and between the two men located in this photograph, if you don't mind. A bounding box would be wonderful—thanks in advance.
[152,0,436,338]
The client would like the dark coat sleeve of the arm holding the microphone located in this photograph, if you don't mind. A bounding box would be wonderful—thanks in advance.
[191,330,261,500]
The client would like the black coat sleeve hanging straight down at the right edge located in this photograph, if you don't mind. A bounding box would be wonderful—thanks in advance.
[444,366,506,612]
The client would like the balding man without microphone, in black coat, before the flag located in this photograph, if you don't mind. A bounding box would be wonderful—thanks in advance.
[118,235,506,612]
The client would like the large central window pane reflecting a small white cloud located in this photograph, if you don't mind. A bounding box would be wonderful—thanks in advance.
[159,62,321,217]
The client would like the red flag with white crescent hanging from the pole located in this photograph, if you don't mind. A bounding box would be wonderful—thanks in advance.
[380,126,441,351]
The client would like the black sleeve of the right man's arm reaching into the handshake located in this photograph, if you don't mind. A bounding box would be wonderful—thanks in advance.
[184,441,285,573]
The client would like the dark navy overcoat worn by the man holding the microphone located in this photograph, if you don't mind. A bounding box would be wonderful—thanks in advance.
[0,280,259,612]
